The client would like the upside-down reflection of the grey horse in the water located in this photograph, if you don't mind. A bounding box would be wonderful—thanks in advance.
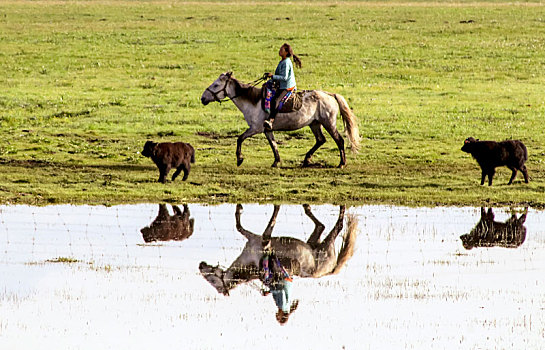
[199,204,357,295]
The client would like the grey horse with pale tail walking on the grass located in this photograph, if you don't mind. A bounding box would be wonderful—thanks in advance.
[201,72,360,168]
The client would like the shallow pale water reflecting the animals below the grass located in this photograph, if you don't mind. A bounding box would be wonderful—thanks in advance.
[0,204,545,349]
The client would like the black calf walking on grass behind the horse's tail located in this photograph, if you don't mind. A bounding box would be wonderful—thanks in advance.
[462,137,528,186]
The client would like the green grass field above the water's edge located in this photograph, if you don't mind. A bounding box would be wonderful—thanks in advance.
[0,1,545,207]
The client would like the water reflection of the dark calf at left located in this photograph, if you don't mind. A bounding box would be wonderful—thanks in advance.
[140,204,195,243]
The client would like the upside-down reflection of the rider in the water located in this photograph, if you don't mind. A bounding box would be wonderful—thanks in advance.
[260,241,299,324]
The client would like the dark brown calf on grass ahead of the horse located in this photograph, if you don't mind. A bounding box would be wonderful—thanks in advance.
[142,141,195,183]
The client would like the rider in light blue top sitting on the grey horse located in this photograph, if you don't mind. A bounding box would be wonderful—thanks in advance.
[263,44,301,130]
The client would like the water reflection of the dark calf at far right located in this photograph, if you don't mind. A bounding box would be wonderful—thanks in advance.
[460,208,528,250]
